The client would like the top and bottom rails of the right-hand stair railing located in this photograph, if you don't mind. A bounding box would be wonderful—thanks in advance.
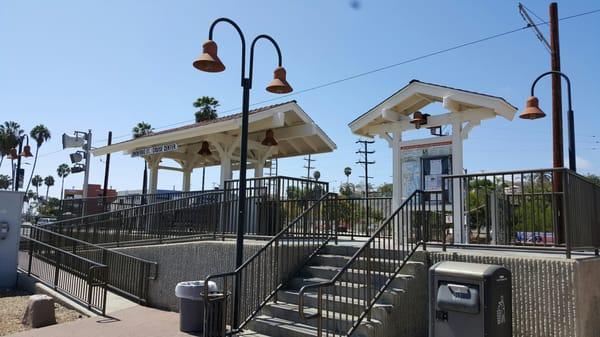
[298,190,424,336]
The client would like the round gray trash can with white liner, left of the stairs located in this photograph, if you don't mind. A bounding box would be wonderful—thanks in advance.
[175,281,221,332]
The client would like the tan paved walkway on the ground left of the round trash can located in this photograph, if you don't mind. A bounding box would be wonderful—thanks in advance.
[9,306,191,337]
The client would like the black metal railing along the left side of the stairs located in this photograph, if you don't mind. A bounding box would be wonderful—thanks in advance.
[204,193,337,335]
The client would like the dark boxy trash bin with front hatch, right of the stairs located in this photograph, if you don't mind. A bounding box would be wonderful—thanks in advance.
[429,262,512,337]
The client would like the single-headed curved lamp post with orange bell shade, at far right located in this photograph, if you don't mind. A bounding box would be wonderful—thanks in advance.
[519,71,577,171]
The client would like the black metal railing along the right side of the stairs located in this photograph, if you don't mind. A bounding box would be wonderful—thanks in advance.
[298,191,438,337]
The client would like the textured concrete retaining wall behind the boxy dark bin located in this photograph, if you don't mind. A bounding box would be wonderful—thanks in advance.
[428,251,600,337]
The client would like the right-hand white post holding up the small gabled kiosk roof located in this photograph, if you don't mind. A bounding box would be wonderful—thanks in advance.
[452,115,469,243]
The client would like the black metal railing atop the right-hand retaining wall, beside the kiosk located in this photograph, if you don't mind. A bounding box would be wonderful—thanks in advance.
[438,168,600,256]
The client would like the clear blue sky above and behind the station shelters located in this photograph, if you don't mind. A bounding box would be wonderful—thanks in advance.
[0,0,600,195]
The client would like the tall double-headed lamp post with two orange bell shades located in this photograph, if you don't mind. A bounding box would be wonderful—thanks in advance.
[193,18,292,324]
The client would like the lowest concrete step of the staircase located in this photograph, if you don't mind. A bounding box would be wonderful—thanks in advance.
[248,315,326,337]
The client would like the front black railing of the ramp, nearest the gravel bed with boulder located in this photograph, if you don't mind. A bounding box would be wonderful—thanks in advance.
[19,237,108,315]
